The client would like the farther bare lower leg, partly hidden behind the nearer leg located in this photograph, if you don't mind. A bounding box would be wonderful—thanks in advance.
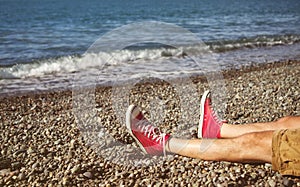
[221,116,300,138]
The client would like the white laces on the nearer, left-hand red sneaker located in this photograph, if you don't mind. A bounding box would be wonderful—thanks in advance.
[137,120,166,157]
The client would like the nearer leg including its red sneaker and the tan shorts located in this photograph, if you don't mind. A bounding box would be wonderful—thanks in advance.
[126,103,300,176]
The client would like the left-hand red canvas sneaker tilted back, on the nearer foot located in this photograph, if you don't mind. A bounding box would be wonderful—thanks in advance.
[126,105,170,155]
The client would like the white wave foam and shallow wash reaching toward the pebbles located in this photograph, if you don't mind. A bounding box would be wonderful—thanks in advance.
[0,42,300,94]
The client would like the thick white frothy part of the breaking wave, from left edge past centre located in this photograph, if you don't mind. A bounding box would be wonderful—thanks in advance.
[0,46,192,79]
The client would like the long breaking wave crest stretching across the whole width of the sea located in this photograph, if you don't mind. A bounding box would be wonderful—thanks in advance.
[0,35,300,79]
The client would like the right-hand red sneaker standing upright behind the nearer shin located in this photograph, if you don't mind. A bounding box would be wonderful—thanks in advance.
[198,91,223,138]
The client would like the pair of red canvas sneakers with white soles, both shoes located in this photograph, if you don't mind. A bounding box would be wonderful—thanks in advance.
[126,91,223,155]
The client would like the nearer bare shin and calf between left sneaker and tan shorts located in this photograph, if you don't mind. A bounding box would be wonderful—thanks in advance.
[166,131,273,163]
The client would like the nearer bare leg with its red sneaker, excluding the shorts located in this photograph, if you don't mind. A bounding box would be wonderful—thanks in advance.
[126,106,272,162]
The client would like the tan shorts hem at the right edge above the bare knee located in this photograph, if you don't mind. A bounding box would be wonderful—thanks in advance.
[272,129,300,176]
